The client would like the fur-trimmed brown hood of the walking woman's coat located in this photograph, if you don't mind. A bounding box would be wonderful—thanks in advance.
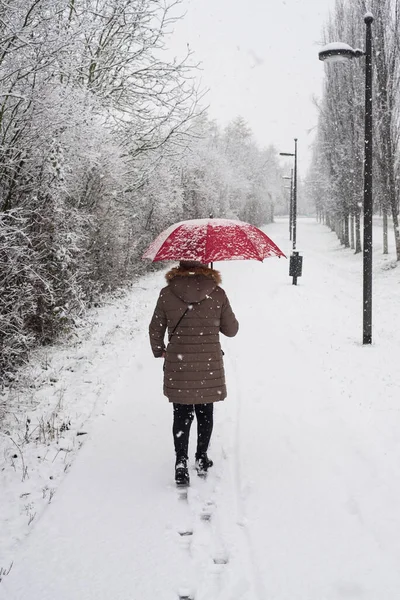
[165,266,221,303]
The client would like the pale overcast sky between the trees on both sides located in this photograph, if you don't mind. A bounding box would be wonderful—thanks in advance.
[167,0,336,176]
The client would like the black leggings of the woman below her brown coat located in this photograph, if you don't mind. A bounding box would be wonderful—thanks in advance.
[172,402,214,459]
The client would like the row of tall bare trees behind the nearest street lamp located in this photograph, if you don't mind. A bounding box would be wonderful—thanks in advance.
[305,0,400,260]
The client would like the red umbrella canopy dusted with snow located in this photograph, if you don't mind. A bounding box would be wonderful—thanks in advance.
[143,219,285,263]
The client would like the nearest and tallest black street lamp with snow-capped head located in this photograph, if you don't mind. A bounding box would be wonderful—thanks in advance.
[318,12,374,344]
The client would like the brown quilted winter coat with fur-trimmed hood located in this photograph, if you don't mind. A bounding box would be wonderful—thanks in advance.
[149,267,239,404]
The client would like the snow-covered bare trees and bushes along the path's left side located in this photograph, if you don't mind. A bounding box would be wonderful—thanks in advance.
[0,0,282,382]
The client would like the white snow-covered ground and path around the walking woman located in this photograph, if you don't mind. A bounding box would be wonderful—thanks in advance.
[0,219,400,600]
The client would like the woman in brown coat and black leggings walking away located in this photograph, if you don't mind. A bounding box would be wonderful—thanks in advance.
[149,261,239,485]
